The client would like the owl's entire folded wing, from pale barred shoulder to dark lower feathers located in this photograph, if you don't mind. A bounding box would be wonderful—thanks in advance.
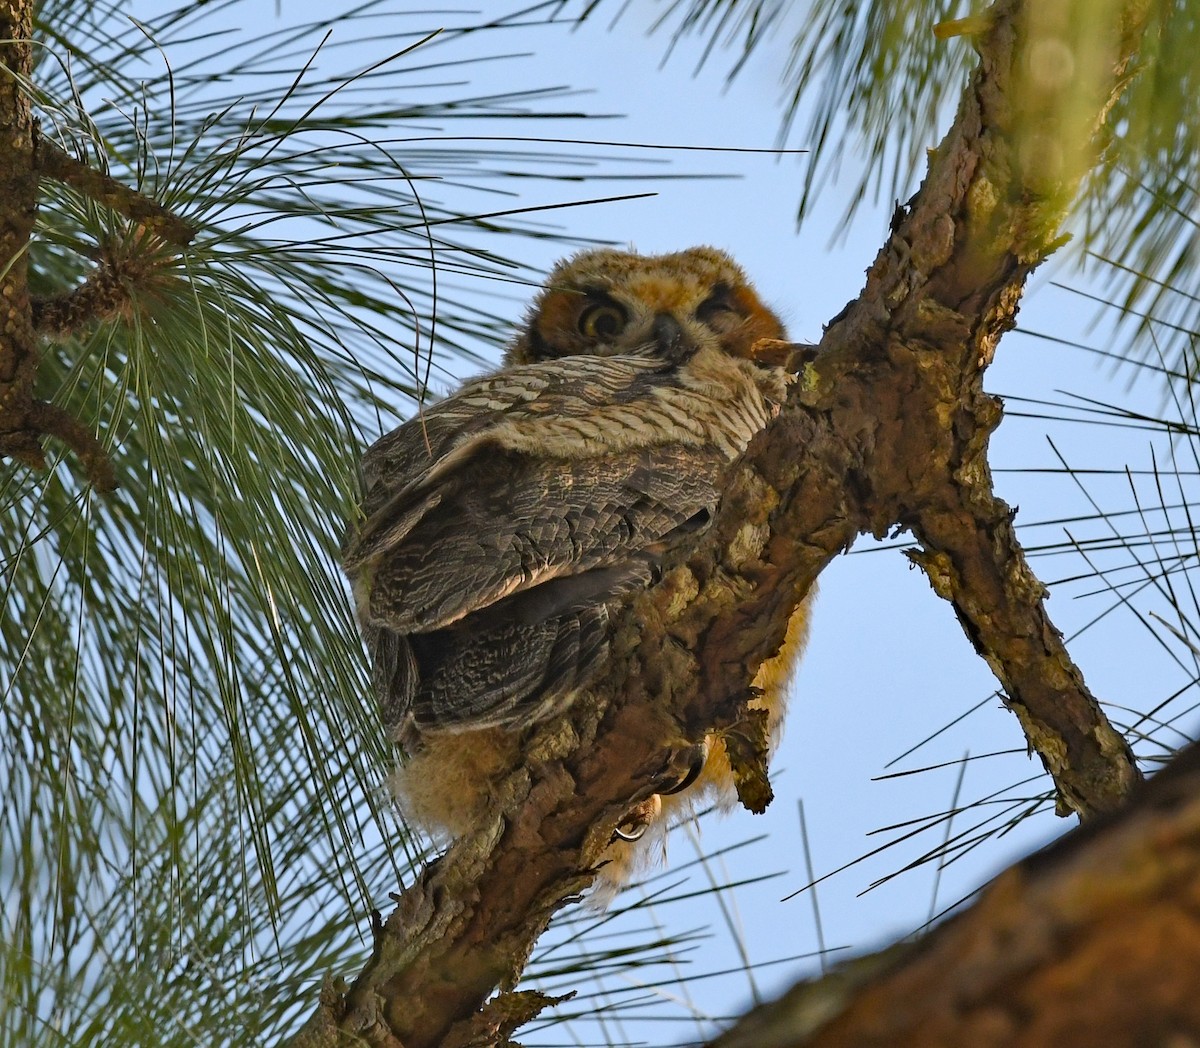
[343,357,766,744]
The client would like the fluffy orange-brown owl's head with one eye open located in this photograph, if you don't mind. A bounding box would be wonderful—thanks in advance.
[505,247,785,364]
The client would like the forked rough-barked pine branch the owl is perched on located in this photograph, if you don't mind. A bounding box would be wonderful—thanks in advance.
[293,0,1148,1048]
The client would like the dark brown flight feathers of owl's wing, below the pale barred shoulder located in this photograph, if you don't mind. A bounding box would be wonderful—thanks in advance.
[365,447,726,734]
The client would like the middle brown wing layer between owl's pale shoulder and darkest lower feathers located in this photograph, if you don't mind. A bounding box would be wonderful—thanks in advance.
[365,445,727,633]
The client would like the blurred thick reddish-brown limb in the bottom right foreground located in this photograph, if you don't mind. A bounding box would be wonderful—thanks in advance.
[712,745,1200,1048]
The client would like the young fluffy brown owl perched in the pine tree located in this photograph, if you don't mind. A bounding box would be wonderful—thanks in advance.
[343,247,806,887]
